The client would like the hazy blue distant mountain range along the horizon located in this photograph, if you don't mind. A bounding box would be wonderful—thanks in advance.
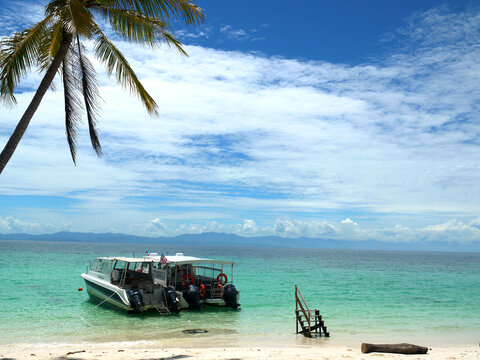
[0,231,480,252]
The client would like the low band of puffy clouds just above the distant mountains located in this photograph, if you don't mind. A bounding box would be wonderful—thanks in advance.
[0,217,480,244]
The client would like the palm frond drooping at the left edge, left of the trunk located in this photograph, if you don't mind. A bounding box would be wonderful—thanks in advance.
[0,16,52,104]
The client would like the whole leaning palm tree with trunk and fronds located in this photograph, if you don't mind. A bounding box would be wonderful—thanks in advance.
[0,0,203,173]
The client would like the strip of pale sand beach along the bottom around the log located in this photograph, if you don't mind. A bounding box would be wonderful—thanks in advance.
[0,343,480,360]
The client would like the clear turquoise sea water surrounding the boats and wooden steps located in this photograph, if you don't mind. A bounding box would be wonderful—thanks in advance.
[0,241,480,346]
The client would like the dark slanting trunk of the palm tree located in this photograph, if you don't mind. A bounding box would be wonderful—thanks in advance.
[0,30,72,174]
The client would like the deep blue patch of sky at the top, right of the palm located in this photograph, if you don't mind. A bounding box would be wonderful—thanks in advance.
[184,0,474,65]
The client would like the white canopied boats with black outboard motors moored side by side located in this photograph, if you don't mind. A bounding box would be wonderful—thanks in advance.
[81,253,240,313]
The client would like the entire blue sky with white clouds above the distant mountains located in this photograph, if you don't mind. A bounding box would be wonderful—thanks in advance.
[0,0,480,243]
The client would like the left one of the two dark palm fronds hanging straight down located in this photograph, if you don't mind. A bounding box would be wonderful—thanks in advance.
[62,47,82,164]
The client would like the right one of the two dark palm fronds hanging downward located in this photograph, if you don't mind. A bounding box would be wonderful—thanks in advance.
[77,36,103,157]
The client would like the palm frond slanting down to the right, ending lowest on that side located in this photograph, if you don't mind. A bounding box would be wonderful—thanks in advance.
[95,29,158,115]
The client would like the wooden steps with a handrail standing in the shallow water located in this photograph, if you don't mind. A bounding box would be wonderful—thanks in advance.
[295,285,330,337]
